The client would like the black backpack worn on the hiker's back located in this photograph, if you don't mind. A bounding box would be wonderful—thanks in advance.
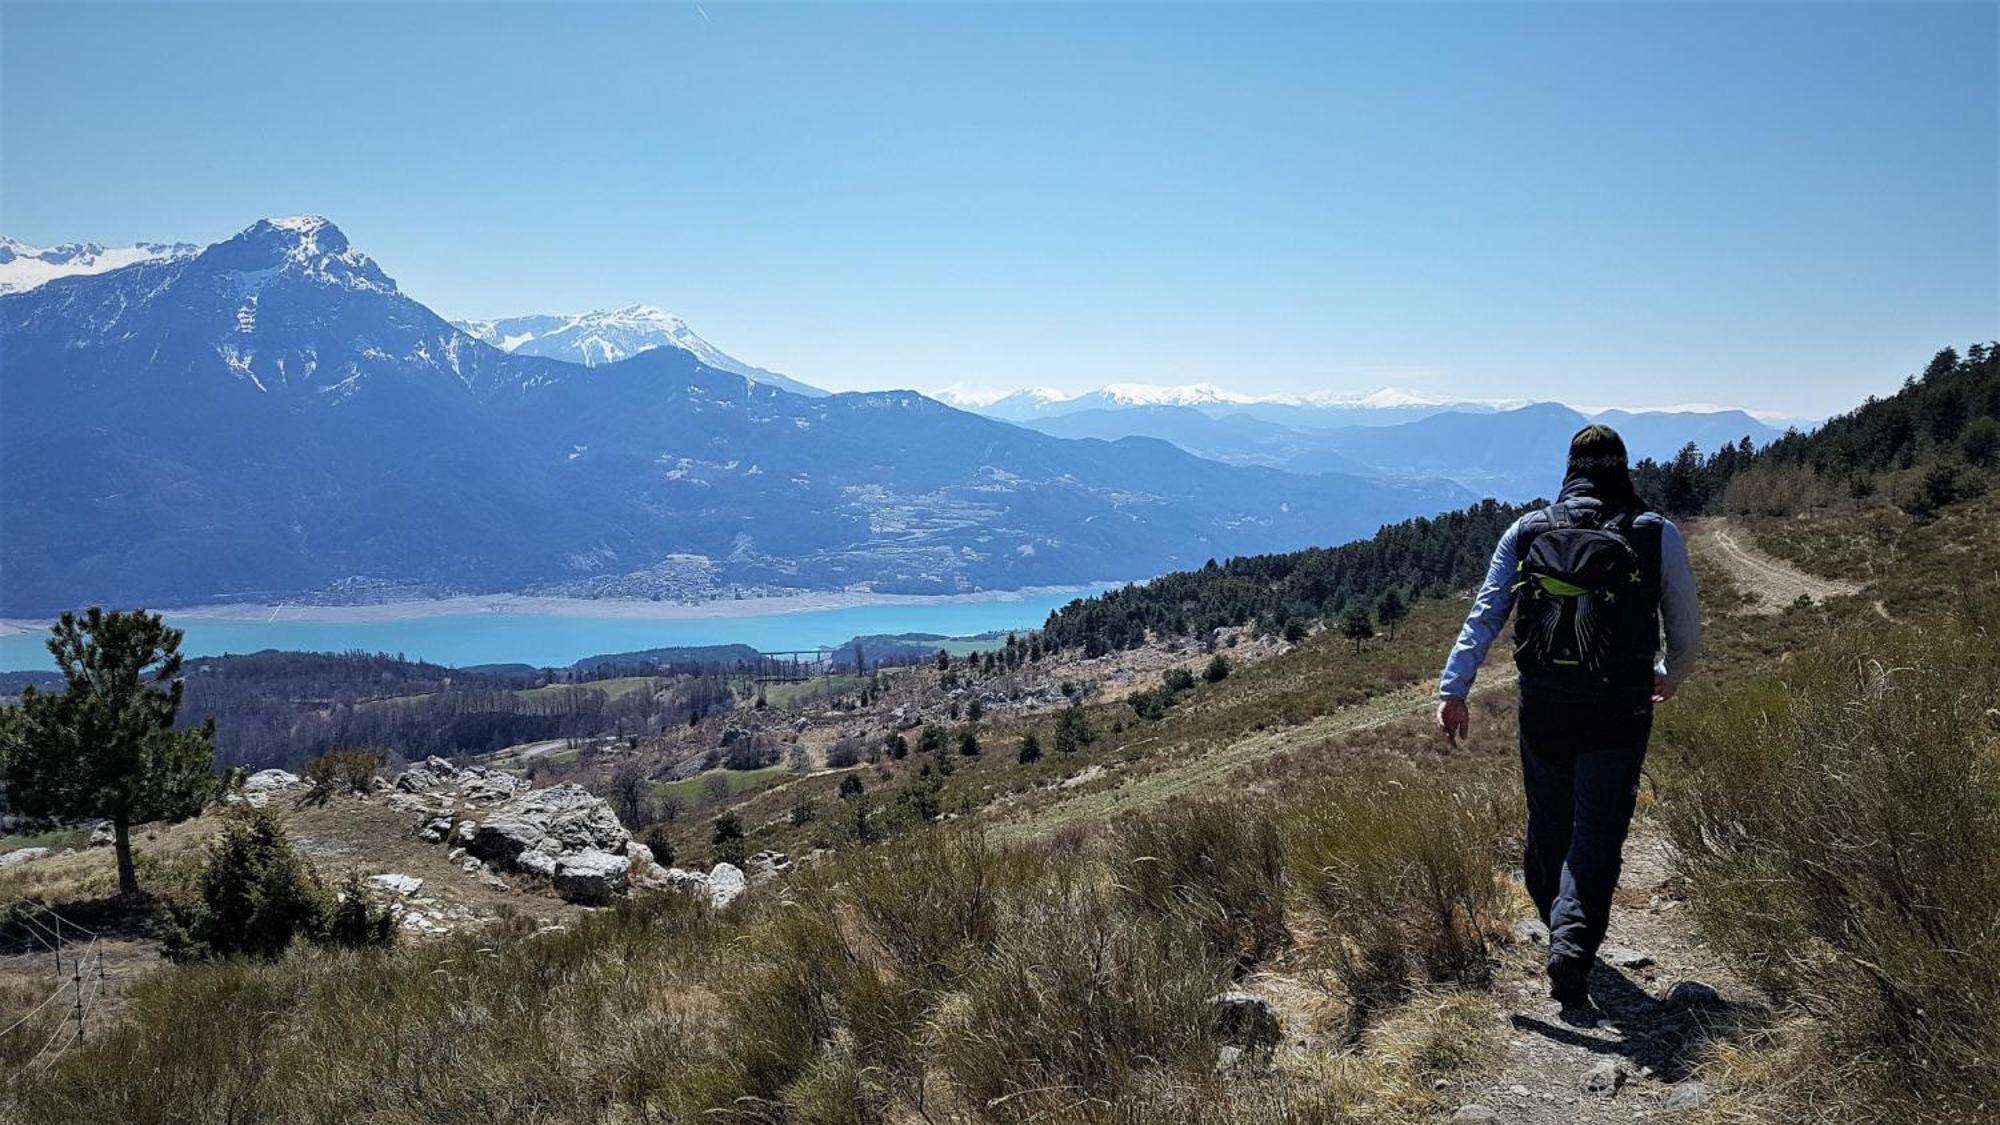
[1514,502,1660,687]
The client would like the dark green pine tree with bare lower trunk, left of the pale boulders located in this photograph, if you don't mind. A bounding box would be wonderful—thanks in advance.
[0,607,222,895]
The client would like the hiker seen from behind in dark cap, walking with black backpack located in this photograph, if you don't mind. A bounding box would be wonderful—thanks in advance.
[1438,426,1702,1009]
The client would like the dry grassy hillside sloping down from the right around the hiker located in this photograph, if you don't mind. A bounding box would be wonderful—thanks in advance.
[0,348,2000,1125]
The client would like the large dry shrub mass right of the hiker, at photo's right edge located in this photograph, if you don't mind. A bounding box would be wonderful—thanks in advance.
[1660,603,2000,1121]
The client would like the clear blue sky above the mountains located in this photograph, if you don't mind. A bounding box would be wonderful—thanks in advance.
[0,0,2000,414]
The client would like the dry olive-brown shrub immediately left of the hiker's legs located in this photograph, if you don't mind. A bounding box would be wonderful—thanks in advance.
[1286,777,1516,1029]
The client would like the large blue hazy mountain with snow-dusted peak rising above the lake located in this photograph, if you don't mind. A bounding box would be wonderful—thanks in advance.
[0,216,1468,615]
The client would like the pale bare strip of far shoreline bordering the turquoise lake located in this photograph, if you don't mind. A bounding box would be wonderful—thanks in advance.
[0,583,1126,637]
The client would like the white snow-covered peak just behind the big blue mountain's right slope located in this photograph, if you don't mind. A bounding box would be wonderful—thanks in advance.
[452,304,826,394]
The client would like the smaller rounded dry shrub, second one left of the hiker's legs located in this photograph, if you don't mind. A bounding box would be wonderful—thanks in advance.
[1112,801,1284,969]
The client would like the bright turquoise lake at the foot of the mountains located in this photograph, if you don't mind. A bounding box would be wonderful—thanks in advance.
[0,591,1112,671]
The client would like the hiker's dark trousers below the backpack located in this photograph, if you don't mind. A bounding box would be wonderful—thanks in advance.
[1520,697,1652,965]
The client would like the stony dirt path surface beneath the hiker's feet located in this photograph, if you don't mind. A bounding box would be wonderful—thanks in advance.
[1444,821,1750,1125]
